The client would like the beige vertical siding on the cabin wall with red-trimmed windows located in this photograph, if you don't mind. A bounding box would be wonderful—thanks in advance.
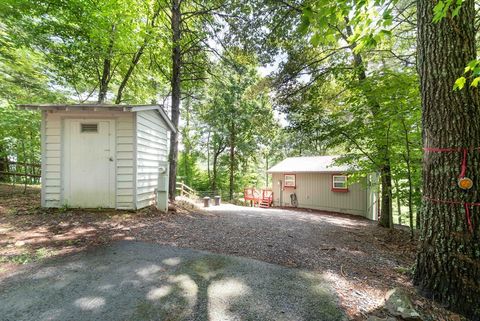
[272,173,368,216]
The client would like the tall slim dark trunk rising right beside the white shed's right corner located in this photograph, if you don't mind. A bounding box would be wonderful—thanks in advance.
[168,0,182,201]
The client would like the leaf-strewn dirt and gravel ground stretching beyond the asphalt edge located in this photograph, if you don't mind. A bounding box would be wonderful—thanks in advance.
[0,185,462,321]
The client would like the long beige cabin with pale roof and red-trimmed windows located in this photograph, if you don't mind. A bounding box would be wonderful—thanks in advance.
[268,156,377,220]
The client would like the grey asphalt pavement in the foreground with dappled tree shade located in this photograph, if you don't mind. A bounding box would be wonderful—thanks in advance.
[0,242,345,321]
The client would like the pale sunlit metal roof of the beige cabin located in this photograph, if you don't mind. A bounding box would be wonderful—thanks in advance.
[267,155,354,174]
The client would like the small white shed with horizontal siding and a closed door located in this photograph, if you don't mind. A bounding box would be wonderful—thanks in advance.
[19,104,176,209]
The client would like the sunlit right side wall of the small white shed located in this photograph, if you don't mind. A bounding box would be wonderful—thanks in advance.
[136,110,168,208]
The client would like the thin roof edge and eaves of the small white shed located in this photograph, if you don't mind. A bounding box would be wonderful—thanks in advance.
[17,104,177,132]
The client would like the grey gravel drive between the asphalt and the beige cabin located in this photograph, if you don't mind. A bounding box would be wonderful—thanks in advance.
[132,204,414,319]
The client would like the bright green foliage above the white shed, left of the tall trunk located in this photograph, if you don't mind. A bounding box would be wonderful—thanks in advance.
[0,0,169,103]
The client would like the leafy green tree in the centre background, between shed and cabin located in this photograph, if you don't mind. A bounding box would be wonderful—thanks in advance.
[178,48,276,197]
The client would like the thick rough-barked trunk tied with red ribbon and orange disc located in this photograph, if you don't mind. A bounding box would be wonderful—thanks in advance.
[414,0,480,320]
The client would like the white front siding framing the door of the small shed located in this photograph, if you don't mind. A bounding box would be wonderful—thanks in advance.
[42,111,135,209]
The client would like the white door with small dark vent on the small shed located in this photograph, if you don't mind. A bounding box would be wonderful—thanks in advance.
[63,119,115,208]
